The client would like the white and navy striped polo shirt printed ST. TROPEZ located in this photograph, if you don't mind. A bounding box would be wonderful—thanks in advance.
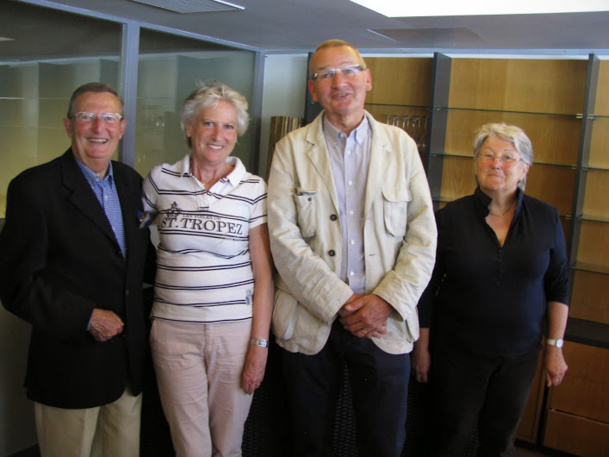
[144,155,267,323]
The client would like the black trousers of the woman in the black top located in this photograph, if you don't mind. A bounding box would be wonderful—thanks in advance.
[430,344,539,457]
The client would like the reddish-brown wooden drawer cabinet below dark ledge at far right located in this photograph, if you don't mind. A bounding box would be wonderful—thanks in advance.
[543,341,609,457]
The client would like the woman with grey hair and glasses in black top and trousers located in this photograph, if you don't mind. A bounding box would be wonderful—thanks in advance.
[413,124,568,456]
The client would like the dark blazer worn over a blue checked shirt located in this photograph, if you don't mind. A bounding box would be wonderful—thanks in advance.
[0,149,154,408]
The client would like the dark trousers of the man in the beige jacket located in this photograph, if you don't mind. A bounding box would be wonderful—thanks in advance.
[282,322,410,457]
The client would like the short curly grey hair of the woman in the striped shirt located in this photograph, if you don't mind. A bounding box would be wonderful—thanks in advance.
[180,81,250,147]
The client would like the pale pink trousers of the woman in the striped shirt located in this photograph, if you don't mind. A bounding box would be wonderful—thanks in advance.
[150,319,252,457]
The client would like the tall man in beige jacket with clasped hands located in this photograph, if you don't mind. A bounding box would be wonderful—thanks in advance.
[268,40,436,457]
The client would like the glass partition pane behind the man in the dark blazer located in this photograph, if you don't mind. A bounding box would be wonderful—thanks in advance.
[0,2,121,218]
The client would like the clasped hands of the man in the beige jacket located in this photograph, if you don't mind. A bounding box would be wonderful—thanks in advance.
[338,294,393,338]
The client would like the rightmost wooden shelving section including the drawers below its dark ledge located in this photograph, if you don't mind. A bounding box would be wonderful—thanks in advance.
[543,56,609,457]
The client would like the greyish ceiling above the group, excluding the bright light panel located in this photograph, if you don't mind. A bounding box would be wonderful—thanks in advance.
[0,0,609,60]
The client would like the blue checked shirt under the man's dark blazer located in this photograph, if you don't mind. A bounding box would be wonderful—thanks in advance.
[76,159,127,257]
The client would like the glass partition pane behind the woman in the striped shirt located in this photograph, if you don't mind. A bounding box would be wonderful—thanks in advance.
[135,29,255,176]
